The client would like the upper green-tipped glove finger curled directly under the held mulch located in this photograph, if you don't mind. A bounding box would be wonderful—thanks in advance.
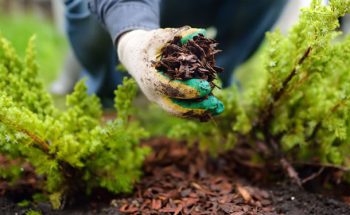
[152,72,212,99]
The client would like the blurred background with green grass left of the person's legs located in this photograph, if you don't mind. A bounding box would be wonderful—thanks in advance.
[0,0,69,88]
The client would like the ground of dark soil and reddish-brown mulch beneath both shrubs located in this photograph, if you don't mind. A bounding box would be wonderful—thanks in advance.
[0,139,350,215]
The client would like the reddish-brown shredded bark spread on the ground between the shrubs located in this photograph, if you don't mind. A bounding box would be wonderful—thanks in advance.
[118,140,276,215]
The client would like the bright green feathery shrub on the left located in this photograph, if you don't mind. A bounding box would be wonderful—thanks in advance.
[0,37,149,208]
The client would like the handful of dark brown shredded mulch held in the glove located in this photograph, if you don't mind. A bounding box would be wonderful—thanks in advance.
[154,34,223,87]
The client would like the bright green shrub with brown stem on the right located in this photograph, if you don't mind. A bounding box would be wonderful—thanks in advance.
[171,0,350,167]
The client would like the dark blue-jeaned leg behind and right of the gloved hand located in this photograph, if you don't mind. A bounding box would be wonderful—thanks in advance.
[161,0,287,87]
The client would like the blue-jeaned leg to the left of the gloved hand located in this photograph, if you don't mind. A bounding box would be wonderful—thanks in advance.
[65,0,123,104]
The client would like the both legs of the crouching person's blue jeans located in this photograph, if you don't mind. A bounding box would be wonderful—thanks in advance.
[66,0,286,99]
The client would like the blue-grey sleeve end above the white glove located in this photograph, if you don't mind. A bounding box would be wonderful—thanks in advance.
[89,0,160,42]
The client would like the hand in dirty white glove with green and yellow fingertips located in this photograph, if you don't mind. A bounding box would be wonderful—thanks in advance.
[118,27,224,120]
